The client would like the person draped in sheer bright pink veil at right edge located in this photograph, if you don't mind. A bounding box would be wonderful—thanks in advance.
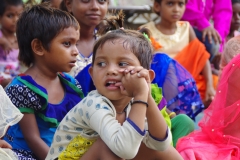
[177,36,240,160]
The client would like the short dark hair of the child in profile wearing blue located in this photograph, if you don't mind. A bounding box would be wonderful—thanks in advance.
[16,3,80,66]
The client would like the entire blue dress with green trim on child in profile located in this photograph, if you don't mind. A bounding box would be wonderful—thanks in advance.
[4,73,83,151]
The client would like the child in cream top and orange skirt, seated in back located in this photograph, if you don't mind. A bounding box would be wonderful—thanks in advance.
[141,0,217,107]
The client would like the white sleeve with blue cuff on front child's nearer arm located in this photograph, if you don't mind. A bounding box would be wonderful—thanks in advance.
[83,96,145,159]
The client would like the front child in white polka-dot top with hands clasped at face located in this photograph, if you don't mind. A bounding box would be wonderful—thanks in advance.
[46,29,181,160]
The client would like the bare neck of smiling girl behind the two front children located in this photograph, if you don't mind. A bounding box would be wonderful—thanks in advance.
[77,26,96,57]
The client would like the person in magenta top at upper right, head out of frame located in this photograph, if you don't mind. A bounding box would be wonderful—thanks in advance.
[182,0,232,60]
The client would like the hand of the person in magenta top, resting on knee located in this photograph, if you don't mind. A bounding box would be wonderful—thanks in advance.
[202,26,221,44]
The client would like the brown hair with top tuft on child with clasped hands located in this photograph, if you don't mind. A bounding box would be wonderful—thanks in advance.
[92,12,153,69]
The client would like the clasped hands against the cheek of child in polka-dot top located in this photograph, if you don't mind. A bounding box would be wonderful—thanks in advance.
[120,69,150,97]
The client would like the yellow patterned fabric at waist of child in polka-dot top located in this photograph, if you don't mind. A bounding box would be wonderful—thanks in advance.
[58,135,96,160]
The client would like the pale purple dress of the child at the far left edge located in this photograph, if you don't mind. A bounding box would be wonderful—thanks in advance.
[0,30,19,76]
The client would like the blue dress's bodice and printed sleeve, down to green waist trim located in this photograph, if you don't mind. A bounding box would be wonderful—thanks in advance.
[6,74,83,127]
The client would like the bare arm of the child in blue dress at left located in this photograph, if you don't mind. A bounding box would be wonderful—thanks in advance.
[19,113,49,160]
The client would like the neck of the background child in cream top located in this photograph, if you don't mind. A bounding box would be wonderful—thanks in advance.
[156,20,177,35]
